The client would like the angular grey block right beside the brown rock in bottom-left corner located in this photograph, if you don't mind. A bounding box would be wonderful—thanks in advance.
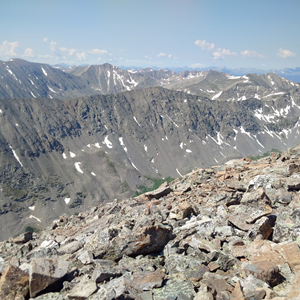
[29,258,69,297]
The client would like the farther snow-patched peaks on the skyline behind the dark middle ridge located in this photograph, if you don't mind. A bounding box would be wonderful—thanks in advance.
[0,59,296,100]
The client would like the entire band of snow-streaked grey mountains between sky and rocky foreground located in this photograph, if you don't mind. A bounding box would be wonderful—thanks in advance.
[0,59,300,240]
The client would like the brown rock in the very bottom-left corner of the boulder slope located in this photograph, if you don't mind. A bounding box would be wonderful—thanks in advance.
[0,265,29,300]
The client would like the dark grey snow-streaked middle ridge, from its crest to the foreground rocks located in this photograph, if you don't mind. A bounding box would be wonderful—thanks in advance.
[0,87,300,238]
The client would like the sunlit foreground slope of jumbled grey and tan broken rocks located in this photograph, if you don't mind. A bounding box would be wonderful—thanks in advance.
[0,146,300,300]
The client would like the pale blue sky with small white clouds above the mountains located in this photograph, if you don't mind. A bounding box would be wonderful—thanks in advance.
[0,0,300,69]
